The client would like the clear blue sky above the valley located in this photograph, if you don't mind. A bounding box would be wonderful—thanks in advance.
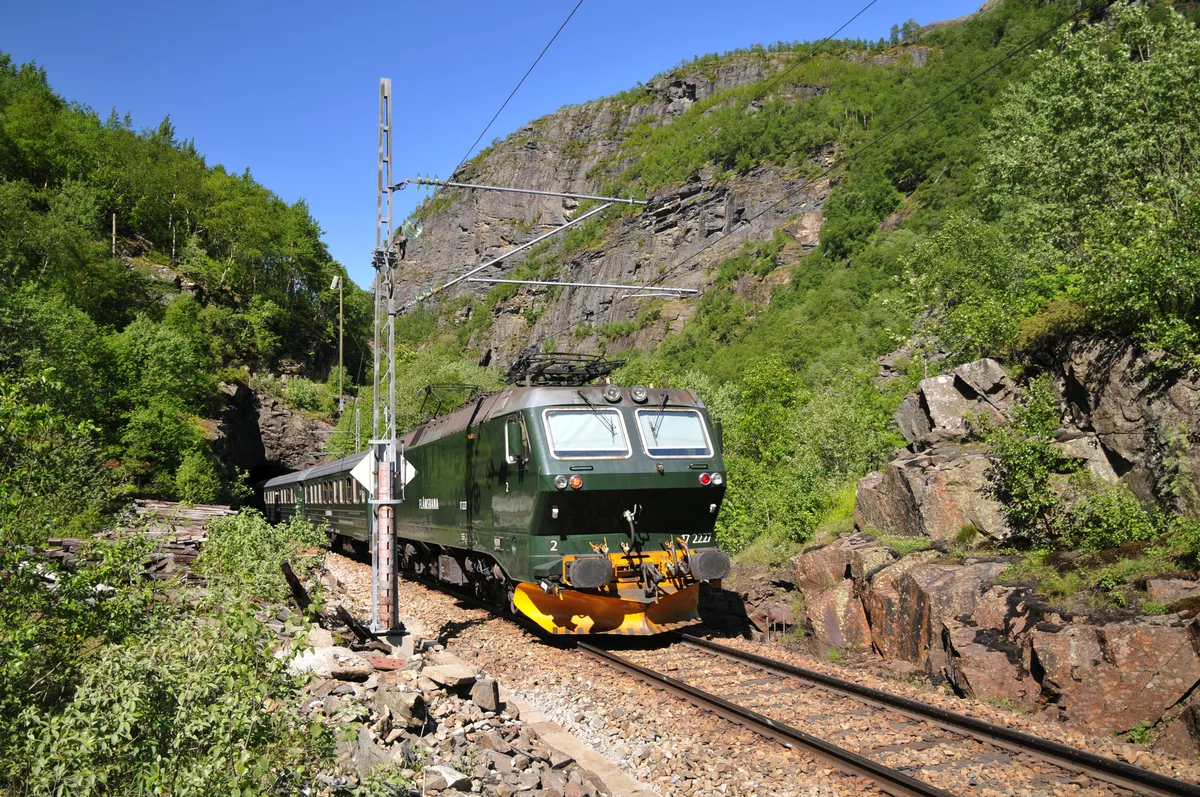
[7,0,979,286]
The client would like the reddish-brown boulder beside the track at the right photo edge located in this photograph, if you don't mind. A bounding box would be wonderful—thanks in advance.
[1027,617,1200,735]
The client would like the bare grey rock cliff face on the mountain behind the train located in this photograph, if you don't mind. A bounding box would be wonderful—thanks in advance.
[398,55,828,364]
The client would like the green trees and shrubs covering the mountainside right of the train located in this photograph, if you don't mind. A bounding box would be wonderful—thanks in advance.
[405,0,1200,559]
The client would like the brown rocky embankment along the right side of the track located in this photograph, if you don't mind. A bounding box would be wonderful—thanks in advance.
[750,341,1200,756]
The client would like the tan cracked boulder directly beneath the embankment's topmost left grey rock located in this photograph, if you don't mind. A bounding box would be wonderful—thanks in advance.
[854,447,1009,541]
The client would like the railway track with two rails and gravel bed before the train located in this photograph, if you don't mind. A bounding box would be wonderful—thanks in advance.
[578,634,1200,797]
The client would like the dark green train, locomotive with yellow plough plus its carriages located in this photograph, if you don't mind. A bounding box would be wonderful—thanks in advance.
[260,385,730,635]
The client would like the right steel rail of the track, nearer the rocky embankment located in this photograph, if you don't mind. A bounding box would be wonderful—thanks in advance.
[678,633,1200,797]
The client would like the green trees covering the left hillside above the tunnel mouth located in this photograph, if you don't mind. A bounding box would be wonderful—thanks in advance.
[0,54,371,511]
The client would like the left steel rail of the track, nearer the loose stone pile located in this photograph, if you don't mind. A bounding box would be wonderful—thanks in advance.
[576,642,954,797]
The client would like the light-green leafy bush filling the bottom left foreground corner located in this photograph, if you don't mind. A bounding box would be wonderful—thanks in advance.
[15,600,334,797]
